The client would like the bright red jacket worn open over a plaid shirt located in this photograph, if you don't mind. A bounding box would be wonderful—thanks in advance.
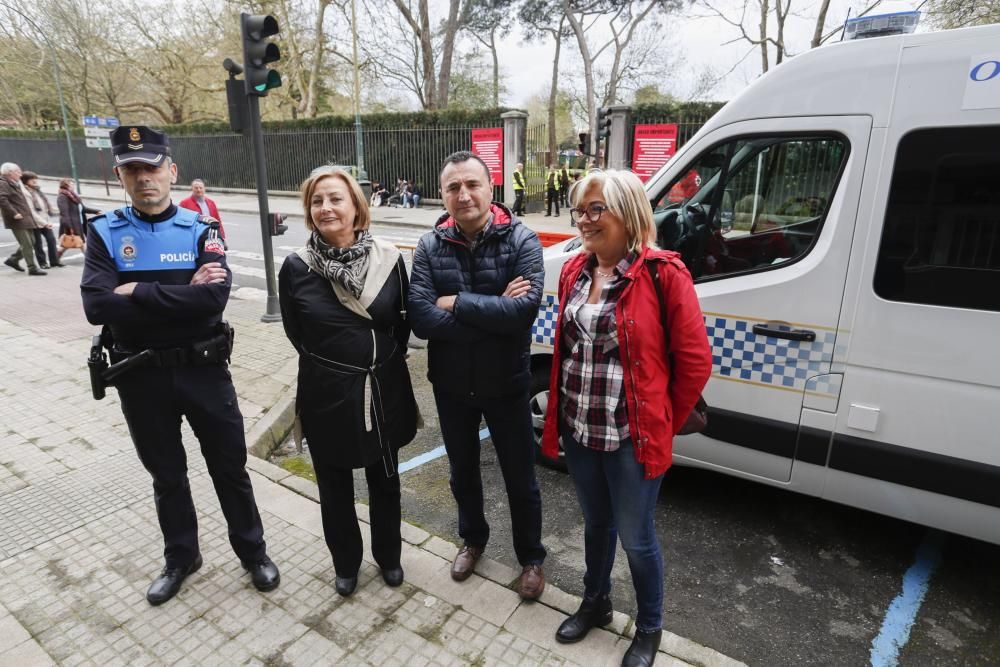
[542,248,712,479]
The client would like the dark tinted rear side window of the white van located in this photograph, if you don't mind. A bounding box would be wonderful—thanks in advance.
[874,126,1000,310]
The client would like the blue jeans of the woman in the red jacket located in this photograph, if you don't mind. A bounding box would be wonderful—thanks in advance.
[559,427,663,632]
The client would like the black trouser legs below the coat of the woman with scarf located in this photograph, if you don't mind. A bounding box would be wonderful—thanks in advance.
[313,459,403,577]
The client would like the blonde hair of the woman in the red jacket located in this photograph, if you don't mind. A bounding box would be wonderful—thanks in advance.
[569,169,656,252]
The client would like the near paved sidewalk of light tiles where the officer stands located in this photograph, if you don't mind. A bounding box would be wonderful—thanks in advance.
[0,205,738,667]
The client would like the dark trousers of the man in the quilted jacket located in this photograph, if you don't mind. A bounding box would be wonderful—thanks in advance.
[434,387,545,565]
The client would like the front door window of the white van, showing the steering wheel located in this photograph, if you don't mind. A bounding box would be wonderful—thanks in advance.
[653,136,848,280]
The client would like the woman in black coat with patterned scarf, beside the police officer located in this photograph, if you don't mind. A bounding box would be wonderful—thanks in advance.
[278,167,419,596]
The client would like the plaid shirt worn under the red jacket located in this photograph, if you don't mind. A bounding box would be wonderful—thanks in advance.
[559,252,638,452]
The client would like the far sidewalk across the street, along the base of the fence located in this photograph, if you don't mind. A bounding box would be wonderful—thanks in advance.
[39,176,576,240]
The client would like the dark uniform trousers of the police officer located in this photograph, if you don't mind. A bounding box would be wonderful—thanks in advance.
[118,364,266,567]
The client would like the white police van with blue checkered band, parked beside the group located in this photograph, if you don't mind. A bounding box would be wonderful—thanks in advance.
[532,20,1000,543]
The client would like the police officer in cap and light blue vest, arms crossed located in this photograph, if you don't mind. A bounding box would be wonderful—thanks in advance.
[80,126,280,605]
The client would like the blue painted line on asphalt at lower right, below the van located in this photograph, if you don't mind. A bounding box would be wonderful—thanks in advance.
[871,530,944,667]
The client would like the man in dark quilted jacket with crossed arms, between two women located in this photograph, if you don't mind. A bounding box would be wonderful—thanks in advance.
[409,151,545,600]
